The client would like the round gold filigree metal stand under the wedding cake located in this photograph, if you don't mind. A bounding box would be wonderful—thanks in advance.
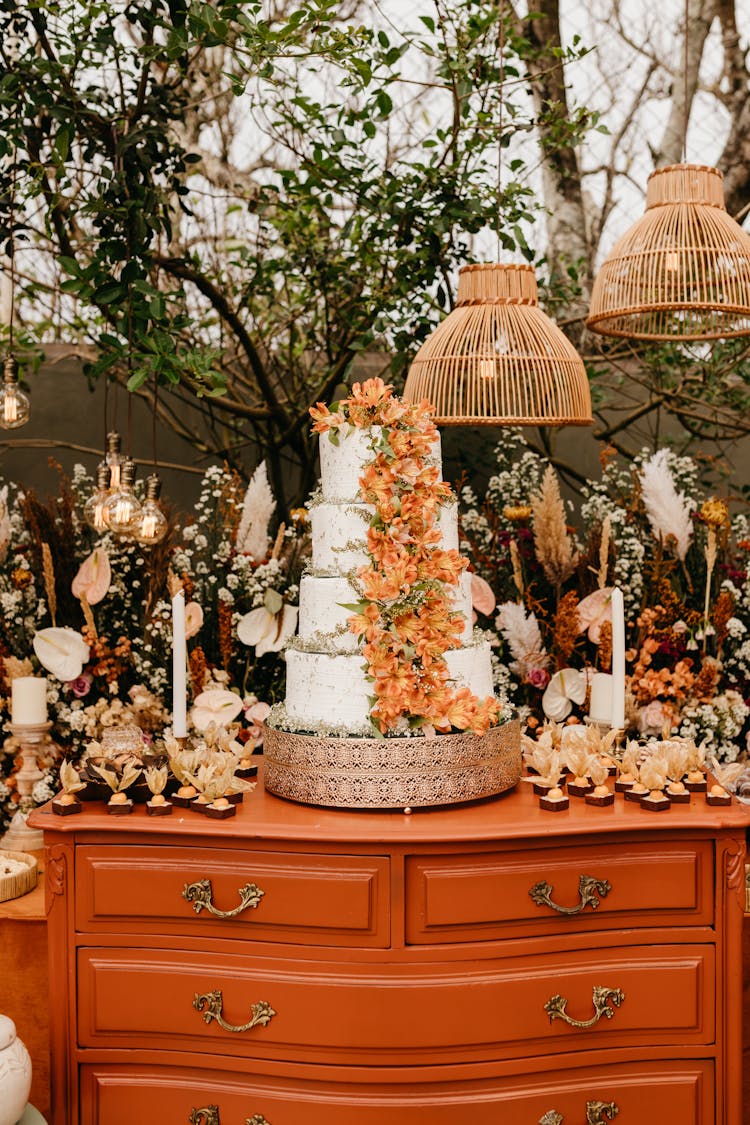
[263,720,521,809]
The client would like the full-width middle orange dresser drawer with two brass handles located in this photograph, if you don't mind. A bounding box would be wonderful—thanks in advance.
[78,945,714,1065]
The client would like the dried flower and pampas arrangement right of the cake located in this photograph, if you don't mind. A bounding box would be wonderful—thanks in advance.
[461,431,750,763]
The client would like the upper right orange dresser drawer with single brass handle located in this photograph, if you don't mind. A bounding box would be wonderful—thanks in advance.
[406,841,714,945]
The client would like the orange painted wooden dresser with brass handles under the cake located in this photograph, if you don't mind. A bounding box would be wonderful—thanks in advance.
[34,769,750,1125]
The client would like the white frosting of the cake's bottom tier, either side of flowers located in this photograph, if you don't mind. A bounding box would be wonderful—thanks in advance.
[287,642,493,729]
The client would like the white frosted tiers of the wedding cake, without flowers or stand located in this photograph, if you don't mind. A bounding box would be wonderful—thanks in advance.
[284,426,493,735]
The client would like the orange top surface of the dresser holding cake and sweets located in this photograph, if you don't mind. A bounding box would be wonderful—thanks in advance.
[29,767,750,844]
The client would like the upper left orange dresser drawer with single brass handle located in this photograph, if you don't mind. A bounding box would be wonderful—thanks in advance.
[75,845,390,947]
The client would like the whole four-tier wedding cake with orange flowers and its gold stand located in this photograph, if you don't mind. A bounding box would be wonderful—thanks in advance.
[264,379,521,808]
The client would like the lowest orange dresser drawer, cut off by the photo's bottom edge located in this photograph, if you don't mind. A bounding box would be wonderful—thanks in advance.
[80,1060,714,1125]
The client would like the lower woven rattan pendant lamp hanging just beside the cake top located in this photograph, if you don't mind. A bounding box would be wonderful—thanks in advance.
[404,258,594,425]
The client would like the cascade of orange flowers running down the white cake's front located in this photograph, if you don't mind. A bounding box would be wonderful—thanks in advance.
[310,379,499,735]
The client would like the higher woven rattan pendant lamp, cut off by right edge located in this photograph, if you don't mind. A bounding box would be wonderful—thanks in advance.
[586,164,750,340]
